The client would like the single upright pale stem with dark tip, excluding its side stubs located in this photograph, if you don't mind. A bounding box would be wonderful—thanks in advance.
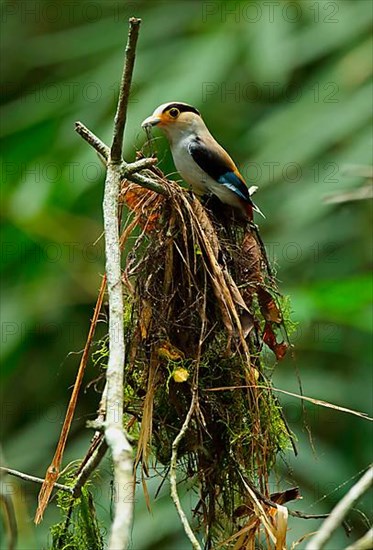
[103,18,141,550]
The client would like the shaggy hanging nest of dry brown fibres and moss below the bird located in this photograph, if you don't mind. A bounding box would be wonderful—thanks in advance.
[112,157,294,548]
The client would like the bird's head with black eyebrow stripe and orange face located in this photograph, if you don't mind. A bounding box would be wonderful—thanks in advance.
[141,101,204,142]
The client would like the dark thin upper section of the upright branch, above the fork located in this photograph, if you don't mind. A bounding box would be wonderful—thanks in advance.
[111,17,141,163]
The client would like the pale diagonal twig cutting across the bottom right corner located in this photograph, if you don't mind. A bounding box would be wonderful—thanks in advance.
[306,466,373,550]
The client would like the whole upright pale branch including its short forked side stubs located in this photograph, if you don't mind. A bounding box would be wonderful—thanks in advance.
[63,18,152,550]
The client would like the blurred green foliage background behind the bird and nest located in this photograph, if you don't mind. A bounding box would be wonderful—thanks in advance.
[1,0,373,550]
